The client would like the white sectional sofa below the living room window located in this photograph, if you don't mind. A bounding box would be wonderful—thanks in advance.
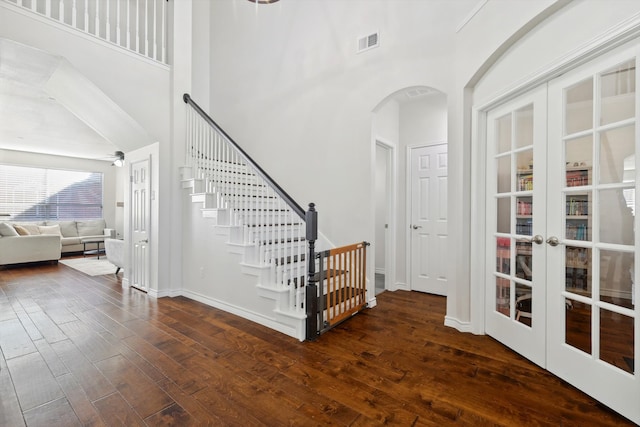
[0,219,113,265]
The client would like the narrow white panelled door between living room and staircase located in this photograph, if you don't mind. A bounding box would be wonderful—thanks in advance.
[130,160,151,291]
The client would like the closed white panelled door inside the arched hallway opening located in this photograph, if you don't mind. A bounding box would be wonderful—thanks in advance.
[409,144,449,295]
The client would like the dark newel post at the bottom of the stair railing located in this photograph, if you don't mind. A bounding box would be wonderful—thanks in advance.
[305,203,318,341]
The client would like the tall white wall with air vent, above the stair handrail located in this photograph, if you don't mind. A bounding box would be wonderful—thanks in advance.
[210,0,464,251]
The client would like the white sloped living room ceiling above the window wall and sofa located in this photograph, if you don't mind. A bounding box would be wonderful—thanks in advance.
[0,38,133,160]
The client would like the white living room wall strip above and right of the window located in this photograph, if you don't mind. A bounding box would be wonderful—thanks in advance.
[0,149,117,233]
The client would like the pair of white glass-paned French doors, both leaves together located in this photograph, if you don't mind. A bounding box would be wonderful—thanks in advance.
[485,47,640,423]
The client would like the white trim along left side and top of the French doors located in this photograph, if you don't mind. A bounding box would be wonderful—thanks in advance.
[469,13,640,334]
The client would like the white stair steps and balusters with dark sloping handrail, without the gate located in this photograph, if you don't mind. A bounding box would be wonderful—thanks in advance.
[181,95,307,340]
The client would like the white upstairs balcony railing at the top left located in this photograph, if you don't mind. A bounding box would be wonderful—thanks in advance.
[0,0,168,64]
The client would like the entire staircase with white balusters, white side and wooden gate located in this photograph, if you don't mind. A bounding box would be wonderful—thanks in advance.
[181,94,368,340]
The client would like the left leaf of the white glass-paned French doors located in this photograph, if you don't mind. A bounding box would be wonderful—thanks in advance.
[485,88,547,366]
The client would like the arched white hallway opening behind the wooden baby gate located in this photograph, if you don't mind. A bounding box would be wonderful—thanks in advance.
[371,86,453,295]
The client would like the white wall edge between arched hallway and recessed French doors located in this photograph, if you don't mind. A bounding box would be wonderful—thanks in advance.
[445,0,566,331]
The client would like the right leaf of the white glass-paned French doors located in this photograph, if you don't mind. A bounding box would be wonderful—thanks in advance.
[547,45,640,424]
